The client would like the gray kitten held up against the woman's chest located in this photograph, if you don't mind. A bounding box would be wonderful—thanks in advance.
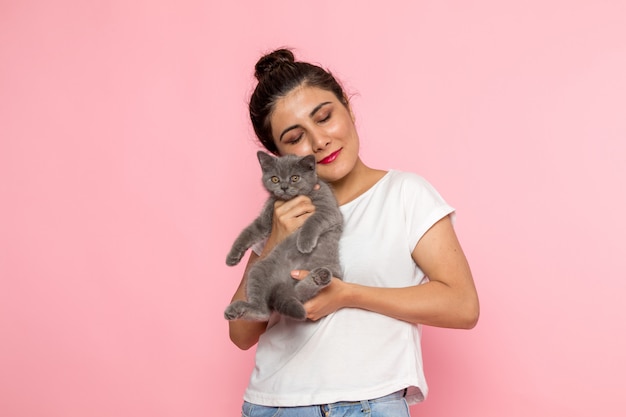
[224,151,343,321]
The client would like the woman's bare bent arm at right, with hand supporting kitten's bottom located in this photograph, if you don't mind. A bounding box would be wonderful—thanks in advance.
[298,216,479,329]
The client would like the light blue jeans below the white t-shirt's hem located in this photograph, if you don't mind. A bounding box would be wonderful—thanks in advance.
[241,390,411,417]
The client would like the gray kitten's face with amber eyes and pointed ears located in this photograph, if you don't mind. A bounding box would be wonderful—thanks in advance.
[257,151,317,200]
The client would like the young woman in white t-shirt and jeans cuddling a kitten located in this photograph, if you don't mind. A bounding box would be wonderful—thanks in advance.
[230,49,479,417]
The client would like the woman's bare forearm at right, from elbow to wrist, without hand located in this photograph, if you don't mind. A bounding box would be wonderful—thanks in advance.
[343,281,479,329]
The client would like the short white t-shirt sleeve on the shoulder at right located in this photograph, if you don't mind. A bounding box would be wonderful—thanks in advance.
[401,174,455,251]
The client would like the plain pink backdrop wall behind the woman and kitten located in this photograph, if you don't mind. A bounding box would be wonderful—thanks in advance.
[0,0,626,417]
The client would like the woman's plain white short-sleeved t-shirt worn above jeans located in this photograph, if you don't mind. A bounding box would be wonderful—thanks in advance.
[244,170,454,407]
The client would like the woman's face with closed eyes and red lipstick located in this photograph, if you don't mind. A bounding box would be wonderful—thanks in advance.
[270,86,359,183]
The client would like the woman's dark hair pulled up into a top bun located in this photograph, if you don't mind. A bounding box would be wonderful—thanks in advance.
[249,49,348,155]
